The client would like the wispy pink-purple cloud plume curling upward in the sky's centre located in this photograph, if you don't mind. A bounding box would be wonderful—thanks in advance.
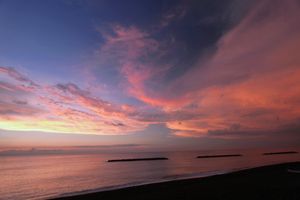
[97,25,170,106]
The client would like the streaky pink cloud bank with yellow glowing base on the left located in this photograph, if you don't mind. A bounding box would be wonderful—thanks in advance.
[0,67,147,135]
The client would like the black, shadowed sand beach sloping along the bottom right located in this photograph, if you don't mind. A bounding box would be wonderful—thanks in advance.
[54,162,300,200]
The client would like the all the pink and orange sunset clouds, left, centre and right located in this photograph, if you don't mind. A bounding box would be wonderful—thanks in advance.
[0,0,300,141]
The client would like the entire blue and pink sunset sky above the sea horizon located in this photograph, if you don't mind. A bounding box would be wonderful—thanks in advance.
[0,0,300,150]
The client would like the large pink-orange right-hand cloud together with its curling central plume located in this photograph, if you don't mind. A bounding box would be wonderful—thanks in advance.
[79,1,300,137]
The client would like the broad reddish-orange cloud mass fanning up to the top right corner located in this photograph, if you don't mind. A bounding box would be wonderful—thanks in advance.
[164,0,300,136]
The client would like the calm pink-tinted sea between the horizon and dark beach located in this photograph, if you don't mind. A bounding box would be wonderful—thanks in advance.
[0,149,300,200]
